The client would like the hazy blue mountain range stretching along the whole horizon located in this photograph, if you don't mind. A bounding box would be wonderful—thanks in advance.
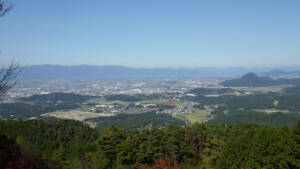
[18,65,300,81]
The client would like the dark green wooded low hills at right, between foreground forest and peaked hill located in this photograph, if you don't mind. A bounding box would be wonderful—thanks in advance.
[184,86,300,126]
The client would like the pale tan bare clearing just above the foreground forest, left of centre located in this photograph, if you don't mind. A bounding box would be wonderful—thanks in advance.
[42,110,114,121]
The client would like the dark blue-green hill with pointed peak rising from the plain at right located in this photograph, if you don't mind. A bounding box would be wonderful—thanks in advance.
[220,73,300,87]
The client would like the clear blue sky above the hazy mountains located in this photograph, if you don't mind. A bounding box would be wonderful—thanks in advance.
[0,0,300,67]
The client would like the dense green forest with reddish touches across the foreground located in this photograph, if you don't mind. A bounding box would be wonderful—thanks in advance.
[0,120,300,169]
